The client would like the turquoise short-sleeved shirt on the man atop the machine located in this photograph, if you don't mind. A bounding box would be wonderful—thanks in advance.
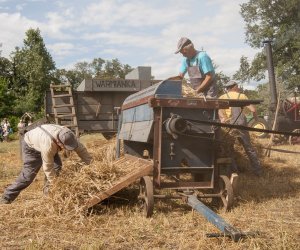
[179,51,215,75]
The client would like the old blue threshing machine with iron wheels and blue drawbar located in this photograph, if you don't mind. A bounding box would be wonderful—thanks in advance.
[118,80,256,241]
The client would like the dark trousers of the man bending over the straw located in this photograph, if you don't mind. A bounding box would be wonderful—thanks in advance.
[3,139,62,202]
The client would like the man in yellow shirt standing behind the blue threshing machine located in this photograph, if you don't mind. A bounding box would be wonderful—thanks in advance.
[219,80,263,176]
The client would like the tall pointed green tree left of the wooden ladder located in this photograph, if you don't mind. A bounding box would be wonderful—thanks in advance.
[12,29,55,113]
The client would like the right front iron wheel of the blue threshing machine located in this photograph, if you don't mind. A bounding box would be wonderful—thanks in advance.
[219,175,234,211]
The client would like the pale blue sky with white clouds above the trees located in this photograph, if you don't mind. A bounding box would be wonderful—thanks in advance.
[0,0,258,89]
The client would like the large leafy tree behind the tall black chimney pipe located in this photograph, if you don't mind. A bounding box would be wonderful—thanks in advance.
[236,0,300,88]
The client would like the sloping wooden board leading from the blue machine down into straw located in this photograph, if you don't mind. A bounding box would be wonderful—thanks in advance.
[85,156,153,208]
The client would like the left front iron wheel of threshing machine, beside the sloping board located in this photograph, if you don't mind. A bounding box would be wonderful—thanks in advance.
[139,176,154,218]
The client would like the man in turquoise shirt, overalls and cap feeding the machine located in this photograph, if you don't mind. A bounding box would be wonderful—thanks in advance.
[175,37,218,98]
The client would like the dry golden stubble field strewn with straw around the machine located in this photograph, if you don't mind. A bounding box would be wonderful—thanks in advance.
[0,135,300,250]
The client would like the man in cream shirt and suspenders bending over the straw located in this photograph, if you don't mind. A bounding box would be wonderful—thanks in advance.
[0,124,92,204]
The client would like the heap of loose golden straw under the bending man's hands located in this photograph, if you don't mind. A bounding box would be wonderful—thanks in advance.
[42,139,138,216]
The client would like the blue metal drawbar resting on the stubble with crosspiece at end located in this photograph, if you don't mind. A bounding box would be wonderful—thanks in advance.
[187,195,253,242]
